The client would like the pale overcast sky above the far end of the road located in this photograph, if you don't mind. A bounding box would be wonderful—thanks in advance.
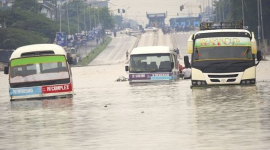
[109,0,211,23]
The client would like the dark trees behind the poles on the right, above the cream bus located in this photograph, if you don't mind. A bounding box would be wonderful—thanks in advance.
[213,0,270,44]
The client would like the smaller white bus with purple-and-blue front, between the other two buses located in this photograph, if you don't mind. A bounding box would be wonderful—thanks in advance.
[125,46,179,83]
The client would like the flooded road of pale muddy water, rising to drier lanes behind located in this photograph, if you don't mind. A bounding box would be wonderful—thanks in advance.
[0,30,270,150]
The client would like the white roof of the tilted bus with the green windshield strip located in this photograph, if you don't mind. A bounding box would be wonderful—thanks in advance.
[10,44,66,60]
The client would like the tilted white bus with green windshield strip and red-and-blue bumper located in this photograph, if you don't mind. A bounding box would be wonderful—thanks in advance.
[4,44,73,100]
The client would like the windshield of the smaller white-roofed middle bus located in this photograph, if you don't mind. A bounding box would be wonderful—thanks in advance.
[130,54,172,73]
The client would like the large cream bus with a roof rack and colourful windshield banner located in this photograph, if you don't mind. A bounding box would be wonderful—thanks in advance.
[185,22,262,87]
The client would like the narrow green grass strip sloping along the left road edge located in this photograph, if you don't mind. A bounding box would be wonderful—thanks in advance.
[78,37,112,66]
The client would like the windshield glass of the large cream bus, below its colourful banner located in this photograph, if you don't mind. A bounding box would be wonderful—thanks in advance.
[194,46,252,61]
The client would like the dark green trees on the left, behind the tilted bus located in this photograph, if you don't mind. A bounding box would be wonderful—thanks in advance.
[0,0,115,49]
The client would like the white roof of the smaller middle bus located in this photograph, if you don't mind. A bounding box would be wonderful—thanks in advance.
[131,46,171,55]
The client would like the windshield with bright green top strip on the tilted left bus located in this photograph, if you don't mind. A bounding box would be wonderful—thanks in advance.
[10,55,69,83]
